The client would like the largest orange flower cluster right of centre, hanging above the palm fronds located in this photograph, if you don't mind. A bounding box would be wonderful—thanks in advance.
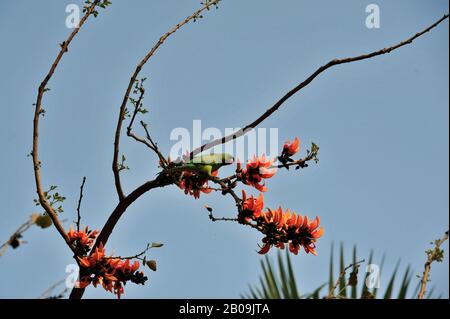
[238,191,323,255]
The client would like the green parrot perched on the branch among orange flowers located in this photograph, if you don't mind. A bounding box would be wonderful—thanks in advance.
[169,153,234,177]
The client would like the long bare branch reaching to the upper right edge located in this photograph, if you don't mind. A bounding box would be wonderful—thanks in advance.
[190,14,448,158]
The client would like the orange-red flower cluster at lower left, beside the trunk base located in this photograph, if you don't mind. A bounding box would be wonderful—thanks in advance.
[68,227,147,298]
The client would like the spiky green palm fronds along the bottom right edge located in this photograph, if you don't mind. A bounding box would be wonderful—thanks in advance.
[241,243,433,299]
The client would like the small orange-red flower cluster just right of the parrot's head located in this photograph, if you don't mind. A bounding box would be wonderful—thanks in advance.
[236,155,277,192]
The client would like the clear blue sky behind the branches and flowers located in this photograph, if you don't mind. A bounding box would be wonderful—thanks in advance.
[0,0,449,298]
